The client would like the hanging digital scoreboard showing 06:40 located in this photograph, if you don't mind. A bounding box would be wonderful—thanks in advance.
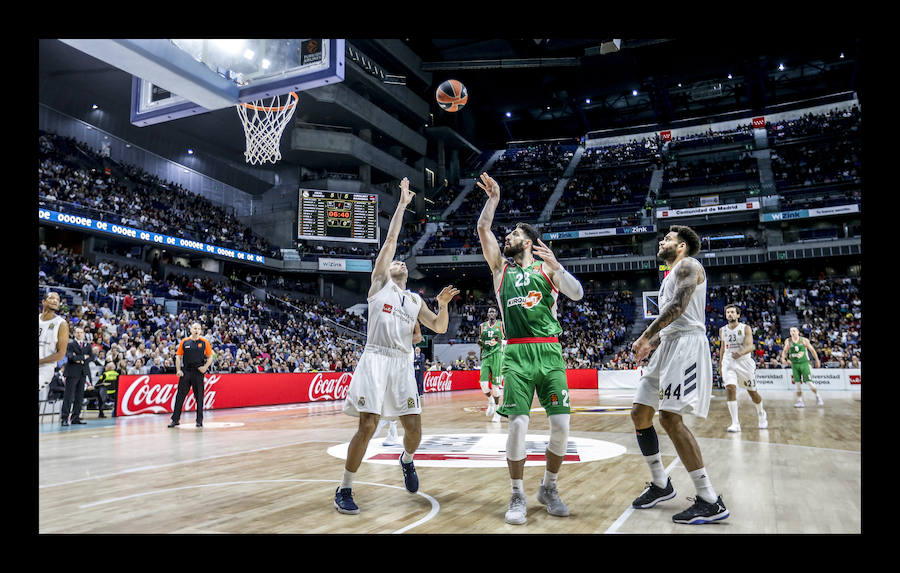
[297,189,380,244]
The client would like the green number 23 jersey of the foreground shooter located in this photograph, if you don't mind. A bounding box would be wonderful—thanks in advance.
[497,261,562,339]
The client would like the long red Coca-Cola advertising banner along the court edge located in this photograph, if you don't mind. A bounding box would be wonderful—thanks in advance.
[116,370,597,416]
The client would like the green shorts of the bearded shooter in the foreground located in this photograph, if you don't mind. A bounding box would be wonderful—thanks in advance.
[497,342,570,416]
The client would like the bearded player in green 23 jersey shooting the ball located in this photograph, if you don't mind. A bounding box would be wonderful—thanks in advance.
[476,173,584,524]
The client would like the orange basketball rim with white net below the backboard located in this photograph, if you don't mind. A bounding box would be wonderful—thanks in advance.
[235,92,300,165]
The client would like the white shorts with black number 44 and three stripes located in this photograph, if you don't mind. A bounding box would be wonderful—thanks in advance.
[634,332,712,418]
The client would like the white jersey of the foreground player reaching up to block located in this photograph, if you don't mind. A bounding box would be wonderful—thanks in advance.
[366,280,422,354]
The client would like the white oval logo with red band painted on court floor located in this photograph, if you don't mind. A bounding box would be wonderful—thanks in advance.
[328,433,626,468]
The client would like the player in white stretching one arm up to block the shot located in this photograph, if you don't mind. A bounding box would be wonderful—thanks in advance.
[334,178,459,514]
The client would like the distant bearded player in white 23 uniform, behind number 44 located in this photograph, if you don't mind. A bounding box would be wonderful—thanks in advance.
[719,304,769,432]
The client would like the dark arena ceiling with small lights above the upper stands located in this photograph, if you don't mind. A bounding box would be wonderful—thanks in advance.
[38,34,861,174]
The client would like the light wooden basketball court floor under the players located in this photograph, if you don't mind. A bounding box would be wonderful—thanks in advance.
[38,390,862,534]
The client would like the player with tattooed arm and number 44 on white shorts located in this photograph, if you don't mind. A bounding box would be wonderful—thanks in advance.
[631,225,729,524]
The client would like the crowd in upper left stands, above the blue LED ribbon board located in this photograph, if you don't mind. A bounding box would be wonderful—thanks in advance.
[38,132,280,258]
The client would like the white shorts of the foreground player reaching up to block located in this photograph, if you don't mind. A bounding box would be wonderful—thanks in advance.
[343,347,422,418]
